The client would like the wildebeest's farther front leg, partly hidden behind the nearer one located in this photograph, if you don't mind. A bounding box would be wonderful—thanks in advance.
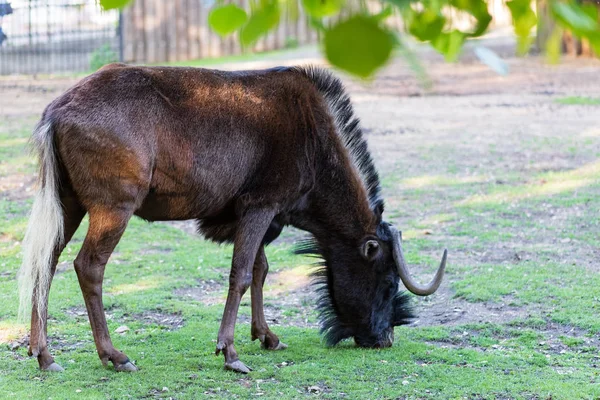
[250,246,287,350]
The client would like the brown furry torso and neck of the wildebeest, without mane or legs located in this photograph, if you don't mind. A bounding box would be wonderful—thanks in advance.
[52,65,375,241]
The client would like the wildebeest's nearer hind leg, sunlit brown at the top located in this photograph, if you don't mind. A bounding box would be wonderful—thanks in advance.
[75,207,137,371]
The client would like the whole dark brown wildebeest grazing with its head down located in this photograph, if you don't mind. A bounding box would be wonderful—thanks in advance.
[19,64,446,372]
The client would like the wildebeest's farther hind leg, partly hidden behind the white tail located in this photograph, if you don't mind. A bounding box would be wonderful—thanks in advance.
[29,193,85,371]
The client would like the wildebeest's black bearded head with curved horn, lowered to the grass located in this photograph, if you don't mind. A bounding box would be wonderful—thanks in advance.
[310,222,447,347]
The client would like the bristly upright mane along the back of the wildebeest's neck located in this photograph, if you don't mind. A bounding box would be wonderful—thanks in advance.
[293,66,383,211]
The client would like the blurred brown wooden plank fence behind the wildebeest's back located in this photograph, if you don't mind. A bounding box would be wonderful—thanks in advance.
[122,0,318,63]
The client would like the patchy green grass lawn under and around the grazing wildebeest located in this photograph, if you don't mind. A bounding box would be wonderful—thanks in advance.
[0,86,600,399]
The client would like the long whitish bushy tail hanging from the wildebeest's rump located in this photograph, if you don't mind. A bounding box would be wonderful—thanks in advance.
[18,120,64,328]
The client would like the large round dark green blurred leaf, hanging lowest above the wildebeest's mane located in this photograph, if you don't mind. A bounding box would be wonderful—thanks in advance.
[323,15,394,78]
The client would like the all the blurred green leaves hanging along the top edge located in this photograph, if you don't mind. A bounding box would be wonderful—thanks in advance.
[100,0,600,78]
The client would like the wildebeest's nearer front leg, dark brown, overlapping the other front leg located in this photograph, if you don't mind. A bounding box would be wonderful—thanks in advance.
[215,209,276,373]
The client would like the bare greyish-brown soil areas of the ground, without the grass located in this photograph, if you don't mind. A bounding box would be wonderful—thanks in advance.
[0,38,600,332]
